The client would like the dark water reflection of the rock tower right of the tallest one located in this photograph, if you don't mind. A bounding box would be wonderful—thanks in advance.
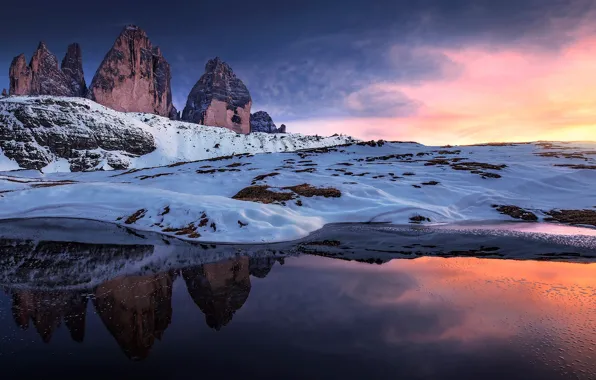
[182,257,251,331]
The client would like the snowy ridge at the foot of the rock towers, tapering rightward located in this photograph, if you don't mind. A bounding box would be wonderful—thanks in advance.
[0,96,352,172]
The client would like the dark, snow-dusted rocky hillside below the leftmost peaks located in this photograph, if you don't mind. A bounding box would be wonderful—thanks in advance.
[0,97,156,171]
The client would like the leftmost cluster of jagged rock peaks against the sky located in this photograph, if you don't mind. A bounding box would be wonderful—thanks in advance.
[9,42,86,96]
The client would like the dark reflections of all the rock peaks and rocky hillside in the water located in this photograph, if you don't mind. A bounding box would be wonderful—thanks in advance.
[0,240,283,360]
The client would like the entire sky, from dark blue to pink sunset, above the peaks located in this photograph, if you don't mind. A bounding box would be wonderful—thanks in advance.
[0,0,596,144]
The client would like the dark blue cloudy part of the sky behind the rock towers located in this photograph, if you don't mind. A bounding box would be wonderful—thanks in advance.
[0,0,596,141]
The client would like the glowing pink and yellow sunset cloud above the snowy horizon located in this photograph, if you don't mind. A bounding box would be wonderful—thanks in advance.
[288,36,596,144]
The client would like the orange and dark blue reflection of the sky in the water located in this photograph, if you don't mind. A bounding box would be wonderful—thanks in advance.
[0,256,596,379]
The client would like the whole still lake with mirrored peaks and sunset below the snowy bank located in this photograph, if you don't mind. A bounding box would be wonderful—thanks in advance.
[0,220,596,380]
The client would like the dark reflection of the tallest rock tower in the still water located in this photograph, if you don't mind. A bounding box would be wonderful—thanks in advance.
[93,272,175,360]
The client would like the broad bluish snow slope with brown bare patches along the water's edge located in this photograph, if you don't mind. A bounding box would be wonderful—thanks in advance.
[0,140,596,243]
